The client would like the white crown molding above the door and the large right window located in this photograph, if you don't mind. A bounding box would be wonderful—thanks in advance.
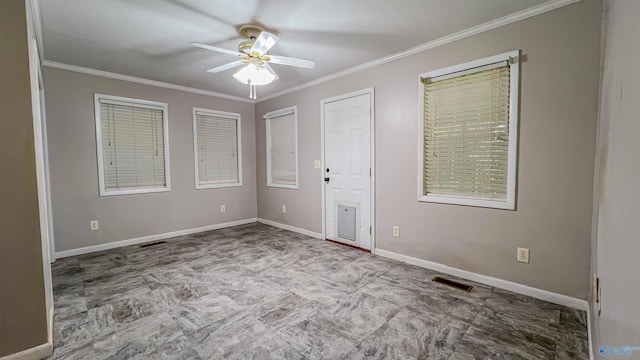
[256,0,582,103]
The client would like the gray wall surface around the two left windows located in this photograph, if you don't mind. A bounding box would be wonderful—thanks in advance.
[44,68,256,251]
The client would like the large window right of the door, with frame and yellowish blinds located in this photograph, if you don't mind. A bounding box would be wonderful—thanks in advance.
[418,51,519,209]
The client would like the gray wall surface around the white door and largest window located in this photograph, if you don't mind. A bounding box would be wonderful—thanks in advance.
[256,0,601,299]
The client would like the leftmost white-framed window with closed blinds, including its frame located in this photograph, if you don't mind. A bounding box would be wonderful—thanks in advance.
[94,94,171,196]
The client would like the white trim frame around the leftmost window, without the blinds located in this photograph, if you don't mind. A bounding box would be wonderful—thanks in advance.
[93,93,171,196]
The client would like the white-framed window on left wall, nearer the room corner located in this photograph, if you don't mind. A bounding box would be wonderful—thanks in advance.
[193,109,242,189]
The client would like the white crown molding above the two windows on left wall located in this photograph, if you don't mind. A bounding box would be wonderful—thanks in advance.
[42,60,255,104]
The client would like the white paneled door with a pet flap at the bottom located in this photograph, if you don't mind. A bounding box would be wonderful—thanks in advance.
[323,92,373,250]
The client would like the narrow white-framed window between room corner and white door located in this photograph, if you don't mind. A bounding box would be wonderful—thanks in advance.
[264,107,298,189]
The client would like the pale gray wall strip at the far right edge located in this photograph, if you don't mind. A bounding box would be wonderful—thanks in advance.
[591,0,640,352]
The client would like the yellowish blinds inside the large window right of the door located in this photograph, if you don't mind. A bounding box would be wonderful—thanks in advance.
[422,62,510,201]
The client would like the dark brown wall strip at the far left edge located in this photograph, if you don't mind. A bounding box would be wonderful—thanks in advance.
[0,0,47,357]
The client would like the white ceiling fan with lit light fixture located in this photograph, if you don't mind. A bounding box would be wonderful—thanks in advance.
[189,25,316,99]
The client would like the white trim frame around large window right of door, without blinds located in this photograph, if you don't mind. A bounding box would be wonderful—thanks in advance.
[418,50,520,210]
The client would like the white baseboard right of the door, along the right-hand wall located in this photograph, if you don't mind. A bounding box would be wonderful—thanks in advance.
[375,249,588,311]
